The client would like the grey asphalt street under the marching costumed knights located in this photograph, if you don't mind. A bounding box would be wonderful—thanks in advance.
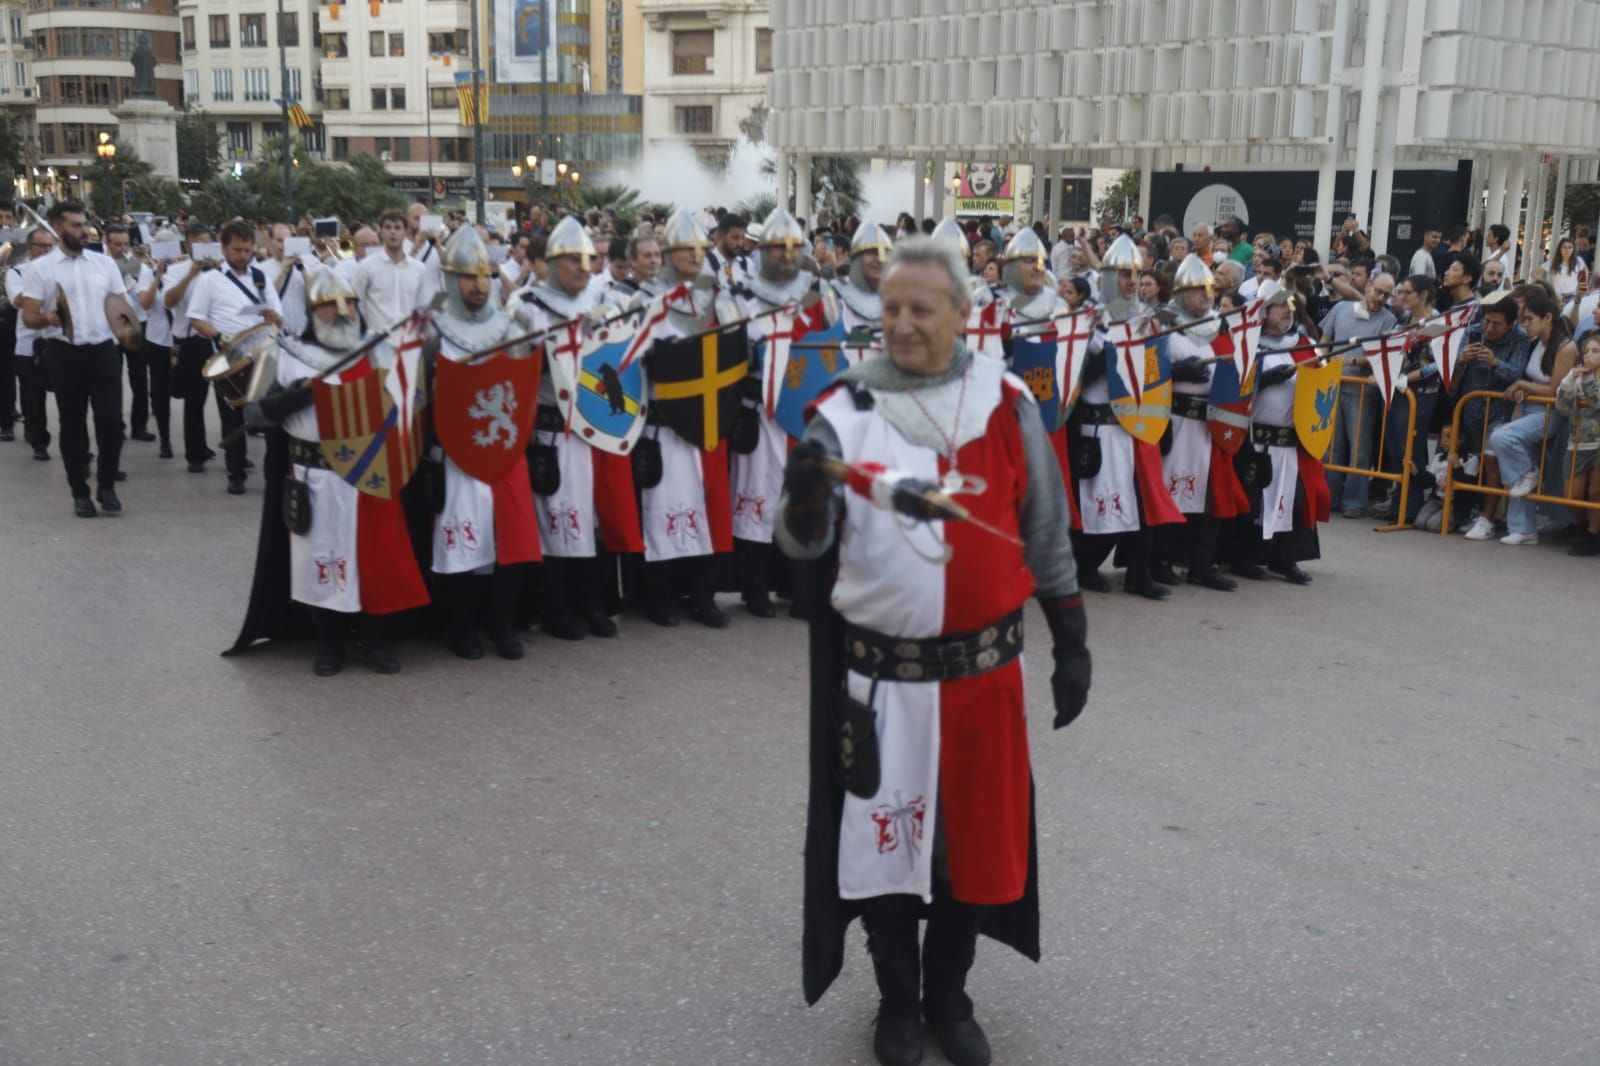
[0,411,1600,1066]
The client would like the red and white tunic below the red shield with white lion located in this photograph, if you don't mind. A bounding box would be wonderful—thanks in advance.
[434,336,541,573]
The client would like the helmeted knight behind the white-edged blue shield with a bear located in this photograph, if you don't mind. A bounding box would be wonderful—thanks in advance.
[517,216,643,640]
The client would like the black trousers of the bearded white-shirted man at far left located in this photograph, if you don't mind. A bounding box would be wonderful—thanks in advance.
[45,341,122,496]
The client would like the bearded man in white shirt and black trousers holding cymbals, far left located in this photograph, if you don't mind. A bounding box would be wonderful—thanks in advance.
[19,200,144,519]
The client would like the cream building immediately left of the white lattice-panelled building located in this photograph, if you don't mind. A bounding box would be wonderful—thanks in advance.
[638,0,768,168]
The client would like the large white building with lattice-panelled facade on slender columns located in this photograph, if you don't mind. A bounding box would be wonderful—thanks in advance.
[768,0,1600,264]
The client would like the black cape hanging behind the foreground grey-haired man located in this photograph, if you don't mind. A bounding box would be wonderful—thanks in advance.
[797,551,1040,1005]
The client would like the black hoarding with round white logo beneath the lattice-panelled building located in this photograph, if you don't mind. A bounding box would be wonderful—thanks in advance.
[1150,160,1472,262]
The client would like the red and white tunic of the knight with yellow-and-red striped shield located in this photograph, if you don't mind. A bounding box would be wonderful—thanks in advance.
[278,336,427,615]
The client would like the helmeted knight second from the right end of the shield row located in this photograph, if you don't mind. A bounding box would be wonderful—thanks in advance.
[1154,253,1250,592]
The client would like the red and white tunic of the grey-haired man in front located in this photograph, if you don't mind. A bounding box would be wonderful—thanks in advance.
[816,357,1036,904]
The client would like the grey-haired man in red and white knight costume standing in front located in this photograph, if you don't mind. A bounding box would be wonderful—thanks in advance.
[778,237,1090,1061]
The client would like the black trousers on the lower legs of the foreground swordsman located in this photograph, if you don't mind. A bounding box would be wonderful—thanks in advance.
[861,877,979,1021]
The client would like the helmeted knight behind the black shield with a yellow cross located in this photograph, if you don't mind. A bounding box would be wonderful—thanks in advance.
[629,208,733,629]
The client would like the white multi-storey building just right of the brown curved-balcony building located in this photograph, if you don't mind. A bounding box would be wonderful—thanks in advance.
[178,0,323,163]
